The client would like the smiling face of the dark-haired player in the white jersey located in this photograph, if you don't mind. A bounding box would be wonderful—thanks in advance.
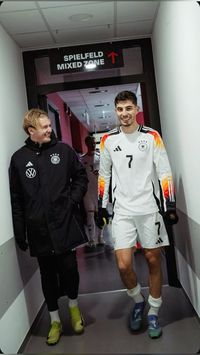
[115,100,138,131]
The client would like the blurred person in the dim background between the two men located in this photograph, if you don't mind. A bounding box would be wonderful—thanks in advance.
[81,136,104,247]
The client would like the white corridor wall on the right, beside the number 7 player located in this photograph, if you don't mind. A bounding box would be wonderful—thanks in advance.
[152,1,200,315]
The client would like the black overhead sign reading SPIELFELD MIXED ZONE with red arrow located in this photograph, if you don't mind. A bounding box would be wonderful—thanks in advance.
[49,45,124,74]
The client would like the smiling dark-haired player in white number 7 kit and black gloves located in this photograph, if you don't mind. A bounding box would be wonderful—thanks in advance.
[97,91,178,338]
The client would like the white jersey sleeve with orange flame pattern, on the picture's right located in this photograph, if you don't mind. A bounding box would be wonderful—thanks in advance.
[152,131,176,212]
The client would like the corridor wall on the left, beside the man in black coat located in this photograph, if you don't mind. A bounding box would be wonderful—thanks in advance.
[0,26,43,353]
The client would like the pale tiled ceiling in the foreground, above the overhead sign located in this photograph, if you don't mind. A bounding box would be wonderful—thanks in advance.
[0,0,159,49]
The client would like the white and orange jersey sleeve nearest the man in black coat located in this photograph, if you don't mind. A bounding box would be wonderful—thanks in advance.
[98,135,112,208]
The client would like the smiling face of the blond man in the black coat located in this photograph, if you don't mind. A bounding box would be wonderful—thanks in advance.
[28,115,52,144]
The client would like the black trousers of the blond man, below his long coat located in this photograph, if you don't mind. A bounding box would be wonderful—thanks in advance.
[37,251,79,312]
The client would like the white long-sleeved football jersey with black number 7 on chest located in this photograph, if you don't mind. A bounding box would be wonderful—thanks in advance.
[98,125,175,215]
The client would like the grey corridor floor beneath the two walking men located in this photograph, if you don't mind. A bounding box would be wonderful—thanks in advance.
[22,226,200,355]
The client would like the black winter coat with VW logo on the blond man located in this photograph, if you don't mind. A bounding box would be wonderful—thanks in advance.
[9,134,88,256]
